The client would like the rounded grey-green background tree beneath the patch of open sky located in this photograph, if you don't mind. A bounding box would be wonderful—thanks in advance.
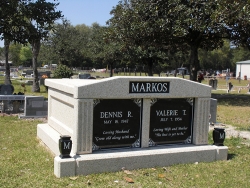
[41,20,90,67]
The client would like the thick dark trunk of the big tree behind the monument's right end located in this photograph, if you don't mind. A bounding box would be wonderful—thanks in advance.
[189,45,200,81]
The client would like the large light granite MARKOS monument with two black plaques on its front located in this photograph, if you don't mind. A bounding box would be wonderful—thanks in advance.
[37,77,228,177]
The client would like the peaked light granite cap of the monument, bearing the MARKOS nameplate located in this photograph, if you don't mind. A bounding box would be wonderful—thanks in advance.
[45,76,211,99]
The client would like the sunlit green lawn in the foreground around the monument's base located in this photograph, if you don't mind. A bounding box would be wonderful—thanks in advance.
[0,116,250,188]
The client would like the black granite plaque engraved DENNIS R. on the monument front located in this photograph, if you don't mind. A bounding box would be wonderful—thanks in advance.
[93,99,141,150]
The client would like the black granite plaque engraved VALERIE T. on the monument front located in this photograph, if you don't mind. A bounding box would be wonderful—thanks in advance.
[149,99,193,146]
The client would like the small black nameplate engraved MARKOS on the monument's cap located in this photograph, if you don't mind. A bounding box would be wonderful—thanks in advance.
[129,82,169,93]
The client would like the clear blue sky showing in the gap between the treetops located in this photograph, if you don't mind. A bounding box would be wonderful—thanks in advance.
[0,0,120,47]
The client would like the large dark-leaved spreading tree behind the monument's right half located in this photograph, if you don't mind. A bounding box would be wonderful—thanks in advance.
[108,0,250,80]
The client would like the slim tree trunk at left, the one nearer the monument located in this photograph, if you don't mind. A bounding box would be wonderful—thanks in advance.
[32,40,41,92]
